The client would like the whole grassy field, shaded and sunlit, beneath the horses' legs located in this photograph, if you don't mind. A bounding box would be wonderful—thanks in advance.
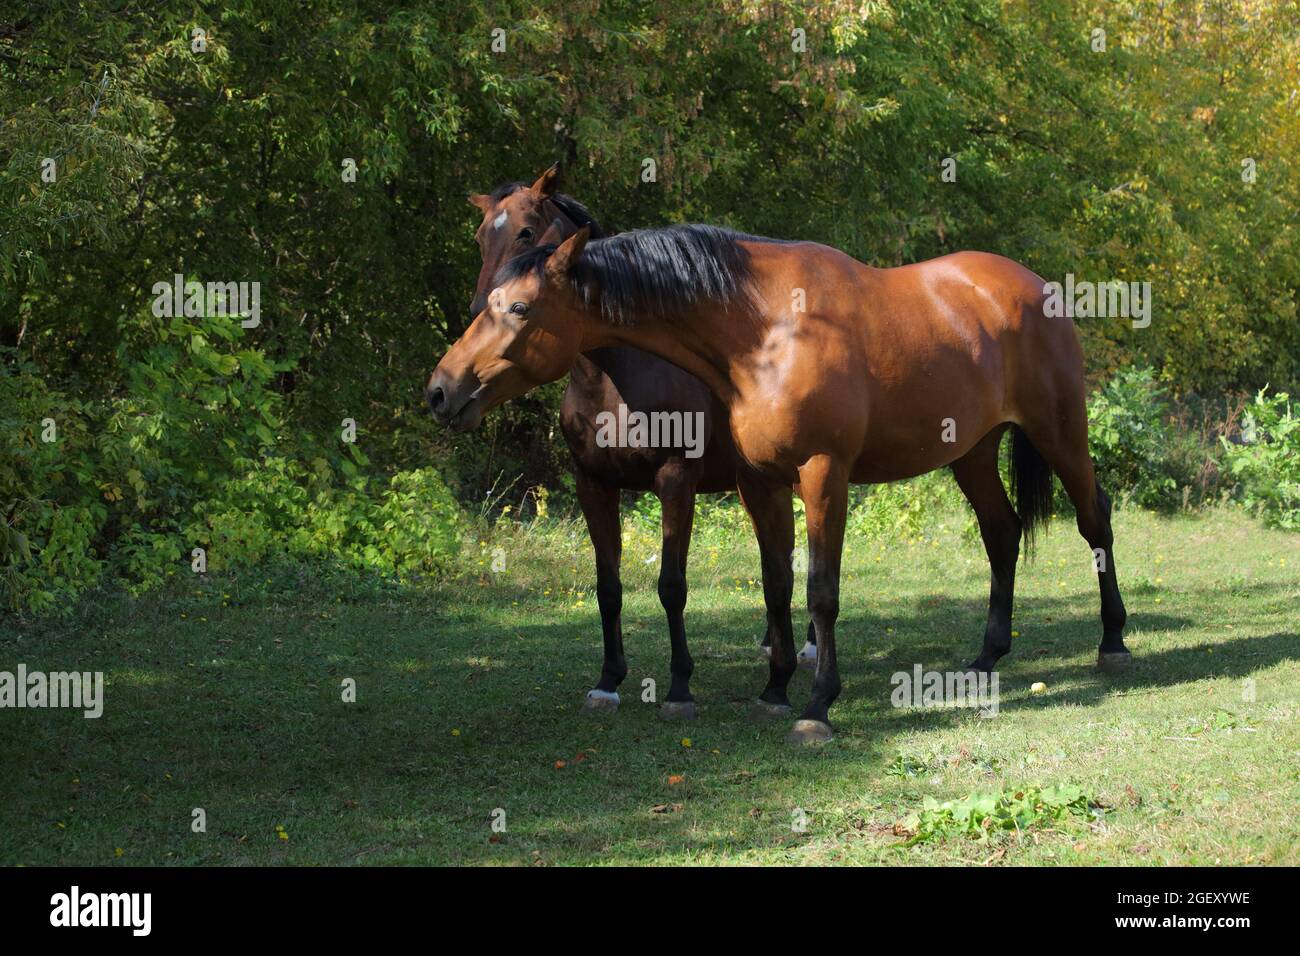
[0,510,1300,866]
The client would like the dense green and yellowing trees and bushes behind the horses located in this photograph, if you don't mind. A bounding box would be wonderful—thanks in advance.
[0,0,1300,607]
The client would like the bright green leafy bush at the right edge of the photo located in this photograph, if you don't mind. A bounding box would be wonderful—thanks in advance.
[1221,389,1300,531]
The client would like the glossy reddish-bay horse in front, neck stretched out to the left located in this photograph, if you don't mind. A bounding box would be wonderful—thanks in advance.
[426,225,1131,743]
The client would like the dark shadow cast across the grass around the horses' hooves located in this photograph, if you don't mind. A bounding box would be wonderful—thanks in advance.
[0,574,1300,864]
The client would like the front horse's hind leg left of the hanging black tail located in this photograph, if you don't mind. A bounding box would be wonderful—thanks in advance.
[952,427,1021,671]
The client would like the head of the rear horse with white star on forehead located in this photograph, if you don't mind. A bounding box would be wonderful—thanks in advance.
[469,163,573,319]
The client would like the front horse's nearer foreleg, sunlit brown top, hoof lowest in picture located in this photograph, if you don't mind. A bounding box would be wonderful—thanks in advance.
[790,455,849,744]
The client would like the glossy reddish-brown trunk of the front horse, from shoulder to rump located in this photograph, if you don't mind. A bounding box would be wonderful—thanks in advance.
[733,243,1082,483]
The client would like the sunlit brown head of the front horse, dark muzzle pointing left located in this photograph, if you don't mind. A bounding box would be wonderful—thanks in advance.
[425,222,589,432]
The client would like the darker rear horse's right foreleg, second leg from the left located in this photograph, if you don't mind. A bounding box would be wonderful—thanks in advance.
[655,459,696,721]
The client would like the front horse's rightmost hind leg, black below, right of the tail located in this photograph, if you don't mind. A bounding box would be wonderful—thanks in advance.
[1024,411,1132,672]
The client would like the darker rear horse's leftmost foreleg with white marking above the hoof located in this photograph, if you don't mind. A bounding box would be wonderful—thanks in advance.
[575,466,628,710]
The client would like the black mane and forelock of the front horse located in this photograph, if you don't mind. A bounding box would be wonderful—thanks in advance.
[494,225,771,325]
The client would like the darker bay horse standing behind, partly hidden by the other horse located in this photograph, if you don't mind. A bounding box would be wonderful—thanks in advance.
[468,163,816,719]
